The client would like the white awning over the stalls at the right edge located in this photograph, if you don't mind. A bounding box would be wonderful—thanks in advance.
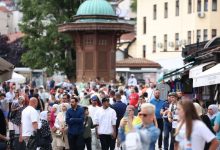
[193,64,220,87]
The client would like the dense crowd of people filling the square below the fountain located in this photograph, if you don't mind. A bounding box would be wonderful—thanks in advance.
[0,75,220,150]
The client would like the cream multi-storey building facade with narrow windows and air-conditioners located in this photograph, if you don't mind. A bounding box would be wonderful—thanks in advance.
[136,0,220,70]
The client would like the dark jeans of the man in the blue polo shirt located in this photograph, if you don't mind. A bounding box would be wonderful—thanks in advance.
[163,120,172,150]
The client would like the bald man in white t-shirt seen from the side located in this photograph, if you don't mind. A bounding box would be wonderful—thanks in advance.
[20,97,39,145]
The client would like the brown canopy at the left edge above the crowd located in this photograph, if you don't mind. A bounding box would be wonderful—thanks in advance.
[0,57,14,82]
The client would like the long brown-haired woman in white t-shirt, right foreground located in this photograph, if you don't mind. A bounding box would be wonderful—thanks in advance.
[175,100,218,150]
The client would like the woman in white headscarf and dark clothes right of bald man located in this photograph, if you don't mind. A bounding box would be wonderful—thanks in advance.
[38,111,52,150]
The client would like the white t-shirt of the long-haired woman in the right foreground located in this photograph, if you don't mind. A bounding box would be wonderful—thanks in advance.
[176,120,215,150]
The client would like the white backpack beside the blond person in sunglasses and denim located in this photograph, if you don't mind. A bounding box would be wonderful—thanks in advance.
[125,132,143,150]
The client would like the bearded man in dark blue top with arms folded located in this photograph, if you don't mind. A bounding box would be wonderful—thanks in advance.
[66,96,84,150]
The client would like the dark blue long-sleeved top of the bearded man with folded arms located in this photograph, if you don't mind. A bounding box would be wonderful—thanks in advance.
[66,106,84,135]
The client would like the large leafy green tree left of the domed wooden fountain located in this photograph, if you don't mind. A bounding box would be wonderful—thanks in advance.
[19,0,82,80]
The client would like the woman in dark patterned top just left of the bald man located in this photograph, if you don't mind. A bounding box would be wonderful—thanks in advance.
[10,96,25,150]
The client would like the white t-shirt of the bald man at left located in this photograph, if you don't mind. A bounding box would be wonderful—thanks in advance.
[21,106,39,136]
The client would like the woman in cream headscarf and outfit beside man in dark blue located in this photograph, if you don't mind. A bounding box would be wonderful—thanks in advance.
[54,103,70,150]
